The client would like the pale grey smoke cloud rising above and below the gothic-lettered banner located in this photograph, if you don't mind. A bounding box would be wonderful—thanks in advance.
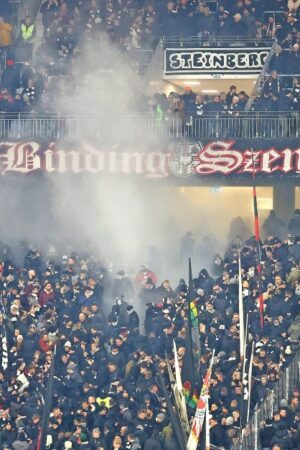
[0,37,270,284]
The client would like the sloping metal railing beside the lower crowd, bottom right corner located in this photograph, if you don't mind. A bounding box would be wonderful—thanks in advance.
[230,350,300,450]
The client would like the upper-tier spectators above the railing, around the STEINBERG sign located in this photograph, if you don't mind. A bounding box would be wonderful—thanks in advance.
[0,0,300,116]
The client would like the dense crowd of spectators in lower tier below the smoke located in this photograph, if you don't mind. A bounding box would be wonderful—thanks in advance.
[0,210,300,450]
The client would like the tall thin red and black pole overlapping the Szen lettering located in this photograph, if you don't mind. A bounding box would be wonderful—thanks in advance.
[251,148,264,329]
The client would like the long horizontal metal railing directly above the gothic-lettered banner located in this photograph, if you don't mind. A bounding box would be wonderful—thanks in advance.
[0,112,300,142]
